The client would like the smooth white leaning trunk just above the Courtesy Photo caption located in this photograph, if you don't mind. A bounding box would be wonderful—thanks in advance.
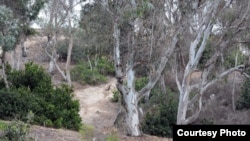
[176,1,222,124]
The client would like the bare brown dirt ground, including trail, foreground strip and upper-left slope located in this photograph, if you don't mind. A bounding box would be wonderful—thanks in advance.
[2,36,172,141]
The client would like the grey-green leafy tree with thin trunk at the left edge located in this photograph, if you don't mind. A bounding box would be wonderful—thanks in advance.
[0,5,19,89]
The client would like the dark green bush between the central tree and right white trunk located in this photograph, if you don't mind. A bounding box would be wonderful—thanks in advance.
[142,88,178,137]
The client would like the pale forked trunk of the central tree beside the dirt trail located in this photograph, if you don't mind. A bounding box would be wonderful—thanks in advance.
[113,17,141,136]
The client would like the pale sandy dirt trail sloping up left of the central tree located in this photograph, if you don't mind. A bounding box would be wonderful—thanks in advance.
[74,78,118,132]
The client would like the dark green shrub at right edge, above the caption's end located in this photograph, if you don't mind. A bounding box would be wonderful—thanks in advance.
[236,79,250,110]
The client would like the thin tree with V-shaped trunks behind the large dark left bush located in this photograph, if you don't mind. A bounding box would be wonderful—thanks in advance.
[41,0,83,85]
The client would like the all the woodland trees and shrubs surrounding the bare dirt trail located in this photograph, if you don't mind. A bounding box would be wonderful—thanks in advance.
[0,0,250,140]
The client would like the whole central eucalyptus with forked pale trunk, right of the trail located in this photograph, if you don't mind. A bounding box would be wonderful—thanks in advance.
[100,0,182,136]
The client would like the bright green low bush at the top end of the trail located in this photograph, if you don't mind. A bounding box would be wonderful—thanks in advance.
[71,63,107,85]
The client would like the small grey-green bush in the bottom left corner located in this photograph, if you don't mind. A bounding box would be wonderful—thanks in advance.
[0,121,30,141]
